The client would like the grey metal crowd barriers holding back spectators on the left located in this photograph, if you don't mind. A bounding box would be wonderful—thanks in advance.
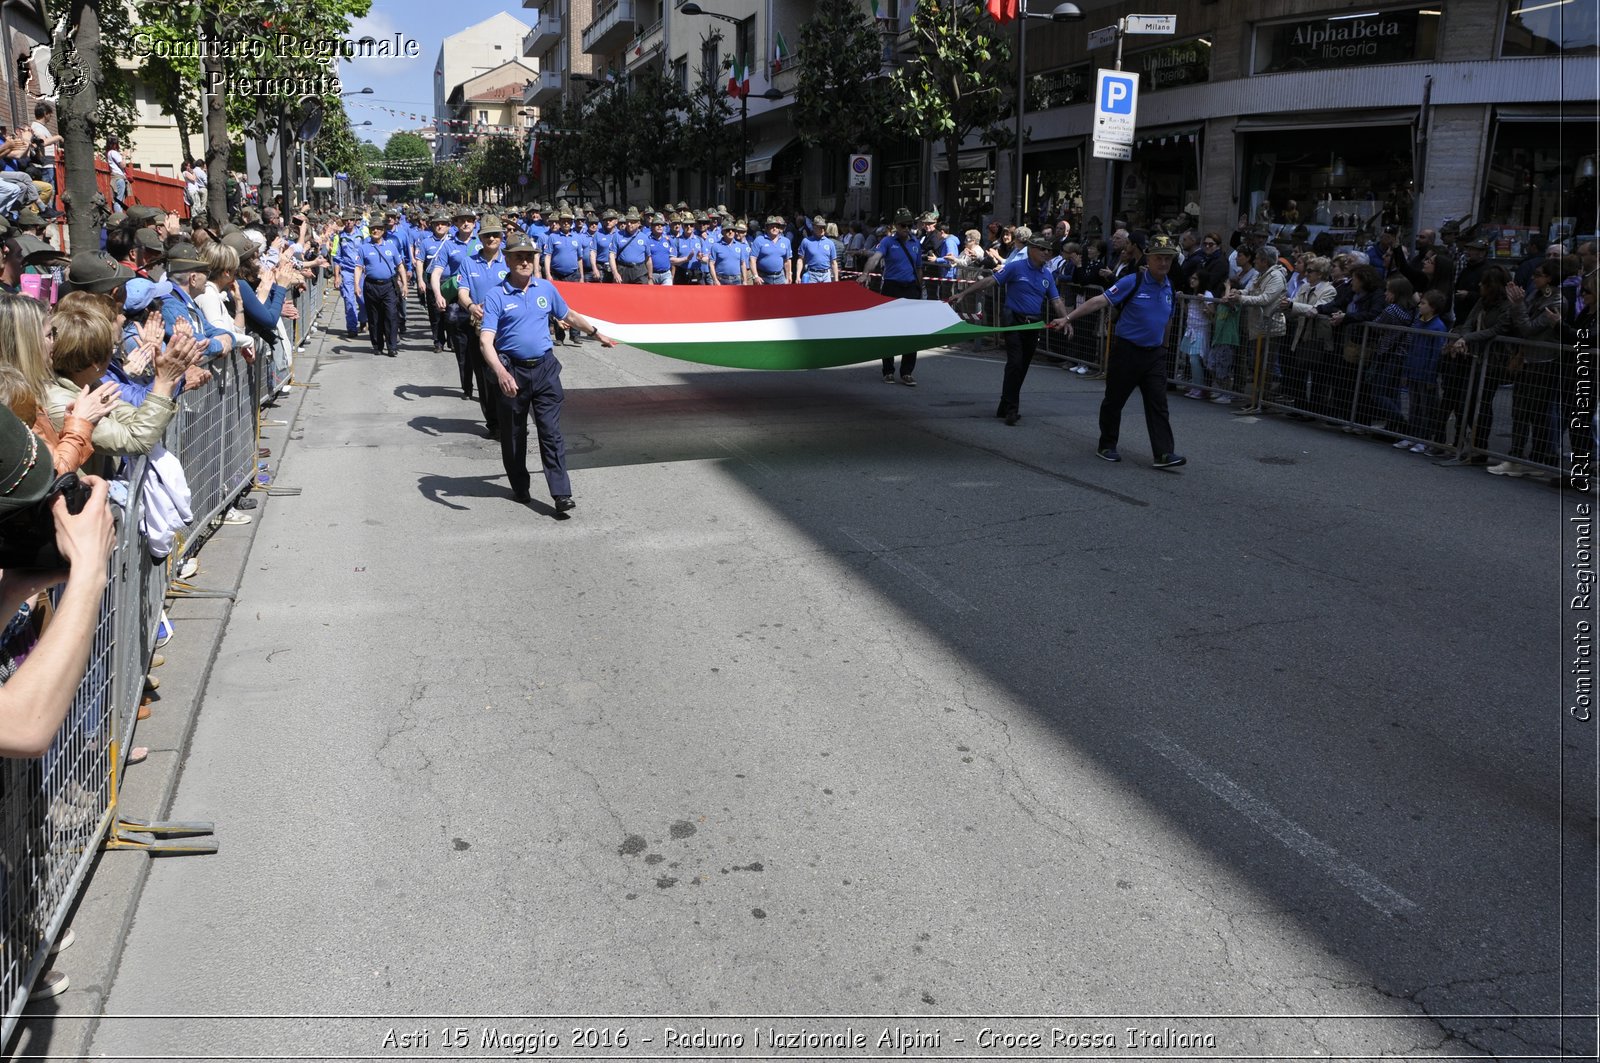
[0,279,323,1045]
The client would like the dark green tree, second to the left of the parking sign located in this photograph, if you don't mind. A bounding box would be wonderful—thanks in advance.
[792,0,890,198]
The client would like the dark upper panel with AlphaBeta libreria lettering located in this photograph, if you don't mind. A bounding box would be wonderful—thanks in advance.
[1250,7,1446,74]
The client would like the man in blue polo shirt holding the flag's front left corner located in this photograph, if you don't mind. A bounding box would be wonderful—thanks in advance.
[478,232,616,514]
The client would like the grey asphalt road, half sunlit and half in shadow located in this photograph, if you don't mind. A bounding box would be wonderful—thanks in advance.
[94,320,1594,1058]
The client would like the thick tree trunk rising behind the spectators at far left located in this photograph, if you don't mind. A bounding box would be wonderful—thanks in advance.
[50,0,106,250]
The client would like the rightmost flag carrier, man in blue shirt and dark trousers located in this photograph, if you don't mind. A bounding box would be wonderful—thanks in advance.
[1062,235,1187,469]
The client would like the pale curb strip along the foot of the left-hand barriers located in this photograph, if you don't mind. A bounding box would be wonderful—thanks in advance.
[0,296,338,1060]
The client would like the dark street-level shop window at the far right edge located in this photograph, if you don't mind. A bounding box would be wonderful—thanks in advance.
[1478,120,1597,256]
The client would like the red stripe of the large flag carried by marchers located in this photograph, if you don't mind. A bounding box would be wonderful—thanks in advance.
[555,280,888,325]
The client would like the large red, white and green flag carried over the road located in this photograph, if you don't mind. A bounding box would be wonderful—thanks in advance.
[555,282,1040,370]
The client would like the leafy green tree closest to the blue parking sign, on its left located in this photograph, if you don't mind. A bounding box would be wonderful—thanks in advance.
[890,0,1014,218]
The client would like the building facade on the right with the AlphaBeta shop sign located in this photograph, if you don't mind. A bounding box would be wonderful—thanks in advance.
[989,0,1600,249]
